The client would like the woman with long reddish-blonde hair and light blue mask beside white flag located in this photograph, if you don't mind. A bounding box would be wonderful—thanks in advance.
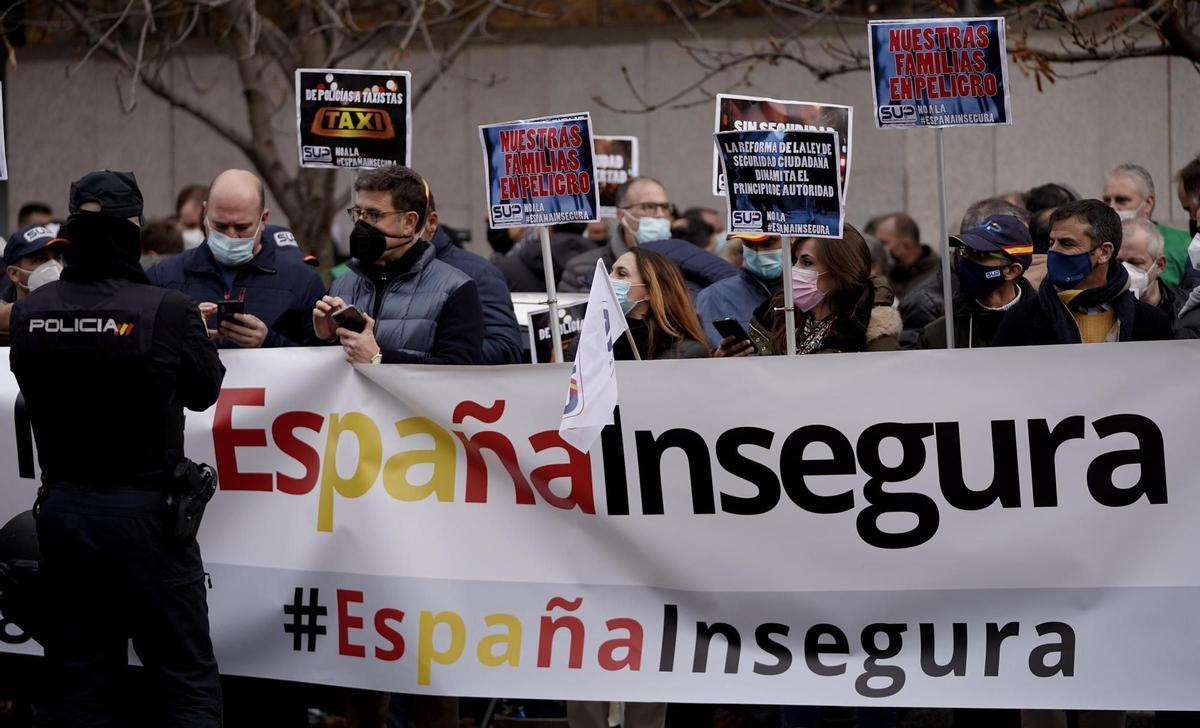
[610,247,708,360]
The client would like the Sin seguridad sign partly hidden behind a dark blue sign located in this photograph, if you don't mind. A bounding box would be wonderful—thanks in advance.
[713,94,854,199]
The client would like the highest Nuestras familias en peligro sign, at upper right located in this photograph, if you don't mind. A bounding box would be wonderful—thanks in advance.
[868,18,1013,128]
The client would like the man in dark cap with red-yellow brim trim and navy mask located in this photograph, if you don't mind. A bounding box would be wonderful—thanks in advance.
[917,215,1037,349]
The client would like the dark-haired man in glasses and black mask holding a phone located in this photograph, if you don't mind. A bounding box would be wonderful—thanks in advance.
[312,166,484,365]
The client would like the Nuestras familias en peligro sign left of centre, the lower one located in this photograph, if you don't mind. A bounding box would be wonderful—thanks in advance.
[479,113,599,229]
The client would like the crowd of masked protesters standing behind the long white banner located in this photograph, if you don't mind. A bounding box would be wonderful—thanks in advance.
[0,156,1200,728]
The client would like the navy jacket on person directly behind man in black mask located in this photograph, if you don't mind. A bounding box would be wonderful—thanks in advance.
[432,228,523,365]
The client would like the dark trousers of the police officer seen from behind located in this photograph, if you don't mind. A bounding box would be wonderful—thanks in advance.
[35,486,221,728]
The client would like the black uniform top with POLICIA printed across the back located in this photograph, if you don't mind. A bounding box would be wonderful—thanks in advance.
[10,278,224,485]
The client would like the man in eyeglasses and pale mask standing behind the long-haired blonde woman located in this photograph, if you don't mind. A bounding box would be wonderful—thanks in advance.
[558,176,737,295]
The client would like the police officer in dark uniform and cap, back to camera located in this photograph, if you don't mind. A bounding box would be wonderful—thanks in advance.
[10,170,224,727]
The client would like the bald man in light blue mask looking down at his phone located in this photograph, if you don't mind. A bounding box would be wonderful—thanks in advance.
[146,169,325,349]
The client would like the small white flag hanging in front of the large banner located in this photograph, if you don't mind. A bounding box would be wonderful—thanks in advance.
[558,259,625,452]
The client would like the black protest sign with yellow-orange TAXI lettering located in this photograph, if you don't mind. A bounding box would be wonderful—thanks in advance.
[296,68,413,168]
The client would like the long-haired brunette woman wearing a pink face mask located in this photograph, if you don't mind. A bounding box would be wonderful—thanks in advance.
[734,224,904,354]
